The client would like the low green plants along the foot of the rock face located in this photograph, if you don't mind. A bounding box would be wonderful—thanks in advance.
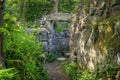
[62,61,120,80]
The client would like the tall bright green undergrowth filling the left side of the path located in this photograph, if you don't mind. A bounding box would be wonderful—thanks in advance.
[0,0,48,80]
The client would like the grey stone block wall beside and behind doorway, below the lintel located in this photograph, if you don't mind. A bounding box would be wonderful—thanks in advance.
[27,27,69,54]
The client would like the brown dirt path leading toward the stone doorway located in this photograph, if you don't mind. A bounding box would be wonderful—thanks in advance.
[45,61,68,80]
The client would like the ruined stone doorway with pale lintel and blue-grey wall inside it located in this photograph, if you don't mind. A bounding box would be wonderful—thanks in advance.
[35,13,70,54]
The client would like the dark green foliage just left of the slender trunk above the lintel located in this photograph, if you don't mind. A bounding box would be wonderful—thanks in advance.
[24,0,53,21]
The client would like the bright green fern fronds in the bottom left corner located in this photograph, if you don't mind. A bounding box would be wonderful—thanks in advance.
[0,68,17,80]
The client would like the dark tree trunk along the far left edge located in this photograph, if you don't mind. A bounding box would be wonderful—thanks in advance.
[0,0,5,69]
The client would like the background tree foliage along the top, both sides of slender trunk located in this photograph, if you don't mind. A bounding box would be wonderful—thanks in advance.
[5,0,78,21]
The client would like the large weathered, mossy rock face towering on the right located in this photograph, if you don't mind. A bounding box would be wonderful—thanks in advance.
[69,0,120,70]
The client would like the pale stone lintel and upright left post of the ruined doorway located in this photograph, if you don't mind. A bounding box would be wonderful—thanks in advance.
[39,13,70,54]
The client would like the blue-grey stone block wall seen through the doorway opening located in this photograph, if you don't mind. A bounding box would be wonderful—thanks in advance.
[53,29,69,53]
